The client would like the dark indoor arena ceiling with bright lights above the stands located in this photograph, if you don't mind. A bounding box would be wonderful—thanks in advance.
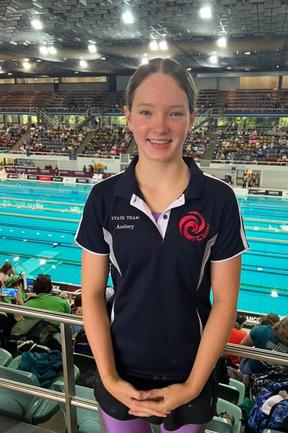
[0,0,288,78]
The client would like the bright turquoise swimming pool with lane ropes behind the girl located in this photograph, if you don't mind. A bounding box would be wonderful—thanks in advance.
[0,180,288,315]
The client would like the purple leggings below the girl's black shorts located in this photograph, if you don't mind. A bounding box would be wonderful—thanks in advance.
[101,410,205,433]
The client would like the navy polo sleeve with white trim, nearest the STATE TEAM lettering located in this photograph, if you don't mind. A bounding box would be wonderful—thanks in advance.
[75,188,109,255]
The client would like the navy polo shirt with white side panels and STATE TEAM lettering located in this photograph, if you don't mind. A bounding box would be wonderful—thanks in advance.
[75,158,247,380]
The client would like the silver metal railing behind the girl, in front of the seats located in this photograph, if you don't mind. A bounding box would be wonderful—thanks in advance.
[0,302,288,433]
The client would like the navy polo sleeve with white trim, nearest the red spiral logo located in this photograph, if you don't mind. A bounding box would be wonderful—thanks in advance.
[210,187,248,262]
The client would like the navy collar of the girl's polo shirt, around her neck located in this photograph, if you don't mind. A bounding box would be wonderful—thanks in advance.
[115,156,204,200]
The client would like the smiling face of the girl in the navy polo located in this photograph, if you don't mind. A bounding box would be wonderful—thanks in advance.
[124,72,194,162]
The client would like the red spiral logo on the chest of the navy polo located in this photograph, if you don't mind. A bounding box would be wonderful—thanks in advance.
[178,211,209,241]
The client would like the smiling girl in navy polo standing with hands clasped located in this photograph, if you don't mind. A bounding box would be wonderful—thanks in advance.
[76,59,247,433]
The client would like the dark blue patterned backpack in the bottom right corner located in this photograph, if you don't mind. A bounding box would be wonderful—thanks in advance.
[248,381,288,433]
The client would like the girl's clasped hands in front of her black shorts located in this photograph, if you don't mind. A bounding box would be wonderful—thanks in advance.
[104,377,197,418]
